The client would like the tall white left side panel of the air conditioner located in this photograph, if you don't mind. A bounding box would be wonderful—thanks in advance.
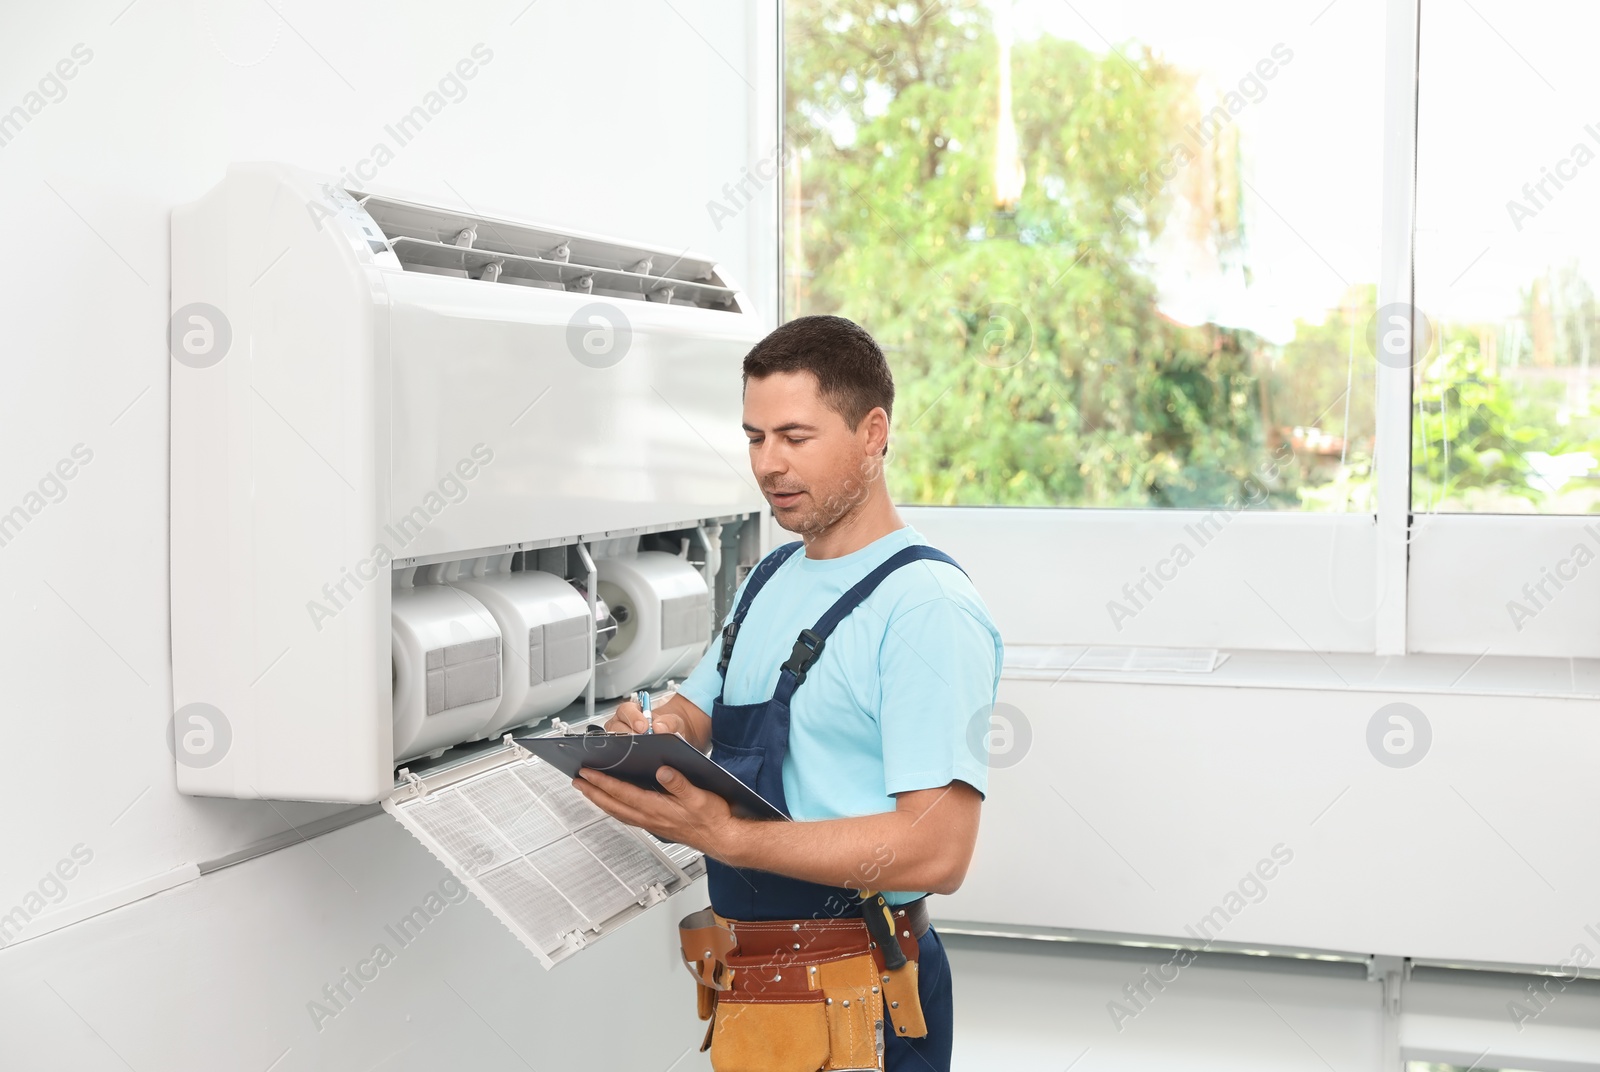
[170,163,400,802]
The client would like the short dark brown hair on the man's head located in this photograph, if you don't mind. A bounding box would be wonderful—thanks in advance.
[744,315,894,432]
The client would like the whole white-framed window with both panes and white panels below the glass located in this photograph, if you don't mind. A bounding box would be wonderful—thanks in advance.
[782,0,1600,659]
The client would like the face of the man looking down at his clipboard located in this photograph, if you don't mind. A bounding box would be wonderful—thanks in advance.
[744,373,888,536]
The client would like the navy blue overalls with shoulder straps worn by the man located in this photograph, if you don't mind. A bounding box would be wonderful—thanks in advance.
[706,542,960,1072]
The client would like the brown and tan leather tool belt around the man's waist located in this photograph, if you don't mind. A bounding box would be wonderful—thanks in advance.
[678,898,928,1072]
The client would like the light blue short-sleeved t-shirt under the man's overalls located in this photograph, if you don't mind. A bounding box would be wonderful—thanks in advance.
[678,525,1003,902]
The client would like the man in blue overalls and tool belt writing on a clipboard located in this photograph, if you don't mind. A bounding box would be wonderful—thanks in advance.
[574,317,1002,1072]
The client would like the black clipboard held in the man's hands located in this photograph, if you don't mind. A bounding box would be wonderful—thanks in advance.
[514,733,789,819]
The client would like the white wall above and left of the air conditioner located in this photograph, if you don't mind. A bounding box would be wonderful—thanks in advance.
[0,0,776,1004]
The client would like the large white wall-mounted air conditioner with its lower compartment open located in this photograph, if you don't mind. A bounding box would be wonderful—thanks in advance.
[170,165,765,802]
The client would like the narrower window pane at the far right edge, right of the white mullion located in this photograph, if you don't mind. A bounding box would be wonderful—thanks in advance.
[1411,0,1600,514]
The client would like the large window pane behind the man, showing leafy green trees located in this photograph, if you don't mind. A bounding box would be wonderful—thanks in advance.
[784,0,1382,510]
